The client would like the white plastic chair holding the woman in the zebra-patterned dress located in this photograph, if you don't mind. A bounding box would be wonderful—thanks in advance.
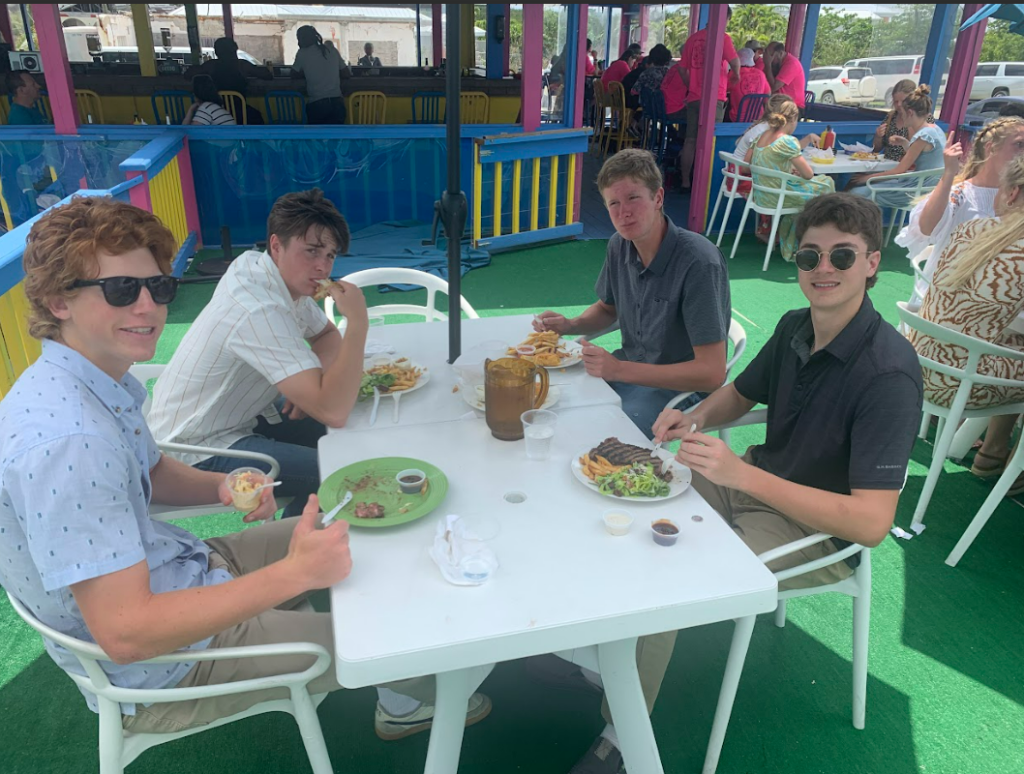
[896,301,1024,532]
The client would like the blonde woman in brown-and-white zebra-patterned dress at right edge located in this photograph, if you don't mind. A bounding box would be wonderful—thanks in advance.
[910,157,1024,496]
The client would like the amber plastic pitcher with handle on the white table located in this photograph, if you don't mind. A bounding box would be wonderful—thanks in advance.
[483,357,548,440]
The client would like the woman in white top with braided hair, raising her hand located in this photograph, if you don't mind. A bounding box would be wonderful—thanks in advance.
[896,117,1024,309]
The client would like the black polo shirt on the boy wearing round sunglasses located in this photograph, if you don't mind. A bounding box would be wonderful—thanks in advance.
[735,296,923,495]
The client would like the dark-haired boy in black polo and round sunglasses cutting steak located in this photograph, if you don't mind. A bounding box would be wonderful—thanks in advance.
[654,194,922,589]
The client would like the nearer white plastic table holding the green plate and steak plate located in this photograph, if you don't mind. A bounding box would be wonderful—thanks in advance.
[319,406,777,774]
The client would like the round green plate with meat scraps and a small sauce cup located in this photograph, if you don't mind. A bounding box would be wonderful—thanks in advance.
[317,457,447,527]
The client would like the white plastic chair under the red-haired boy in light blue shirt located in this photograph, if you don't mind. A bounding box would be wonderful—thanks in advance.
[7,592,334,774]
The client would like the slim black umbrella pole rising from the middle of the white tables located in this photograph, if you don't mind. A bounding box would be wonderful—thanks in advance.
[434,3,469,362]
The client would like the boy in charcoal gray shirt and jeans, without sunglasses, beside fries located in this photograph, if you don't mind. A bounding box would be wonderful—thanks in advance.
[535,149,731,437]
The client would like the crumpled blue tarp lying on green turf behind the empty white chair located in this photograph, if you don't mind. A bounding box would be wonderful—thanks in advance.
[331,220,490,292]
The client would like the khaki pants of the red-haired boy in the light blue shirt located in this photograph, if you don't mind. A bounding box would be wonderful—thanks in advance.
[122,519,434,733]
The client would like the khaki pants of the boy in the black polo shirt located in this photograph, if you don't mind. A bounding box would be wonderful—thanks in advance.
[626,456,853,723]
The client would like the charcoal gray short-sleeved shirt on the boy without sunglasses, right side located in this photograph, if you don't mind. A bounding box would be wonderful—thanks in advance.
[595,217,732,366]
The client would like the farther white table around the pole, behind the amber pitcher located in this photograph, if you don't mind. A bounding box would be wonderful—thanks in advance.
[328,314,622,434]
